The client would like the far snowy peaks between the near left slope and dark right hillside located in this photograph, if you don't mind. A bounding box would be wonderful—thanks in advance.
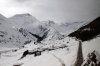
[10,14,86,40]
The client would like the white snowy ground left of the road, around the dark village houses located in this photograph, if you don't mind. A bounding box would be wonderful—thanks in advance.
[0,37,78,66]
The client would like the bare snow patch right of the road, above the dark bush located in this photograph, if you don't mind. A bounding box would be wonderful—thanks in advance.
[83,37,100,61]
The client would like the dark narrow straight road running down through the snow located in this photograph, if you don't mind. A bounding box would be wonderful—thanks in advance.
[74,41,83,66]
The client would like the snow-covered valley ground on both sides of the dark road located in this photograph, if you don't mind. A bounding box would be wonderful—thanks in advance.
[0,37,100,66]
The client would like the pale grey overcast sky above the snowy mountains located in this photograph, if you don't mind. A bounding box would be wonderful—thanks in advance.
[0,0,100,22]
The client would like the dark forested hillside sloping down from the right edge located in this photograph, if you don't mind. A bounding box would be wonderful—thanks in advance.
[69,17,100,41]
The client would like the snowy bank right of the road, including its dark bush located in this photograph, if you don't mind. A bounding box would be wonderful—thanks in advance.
[82,37,100,66]
